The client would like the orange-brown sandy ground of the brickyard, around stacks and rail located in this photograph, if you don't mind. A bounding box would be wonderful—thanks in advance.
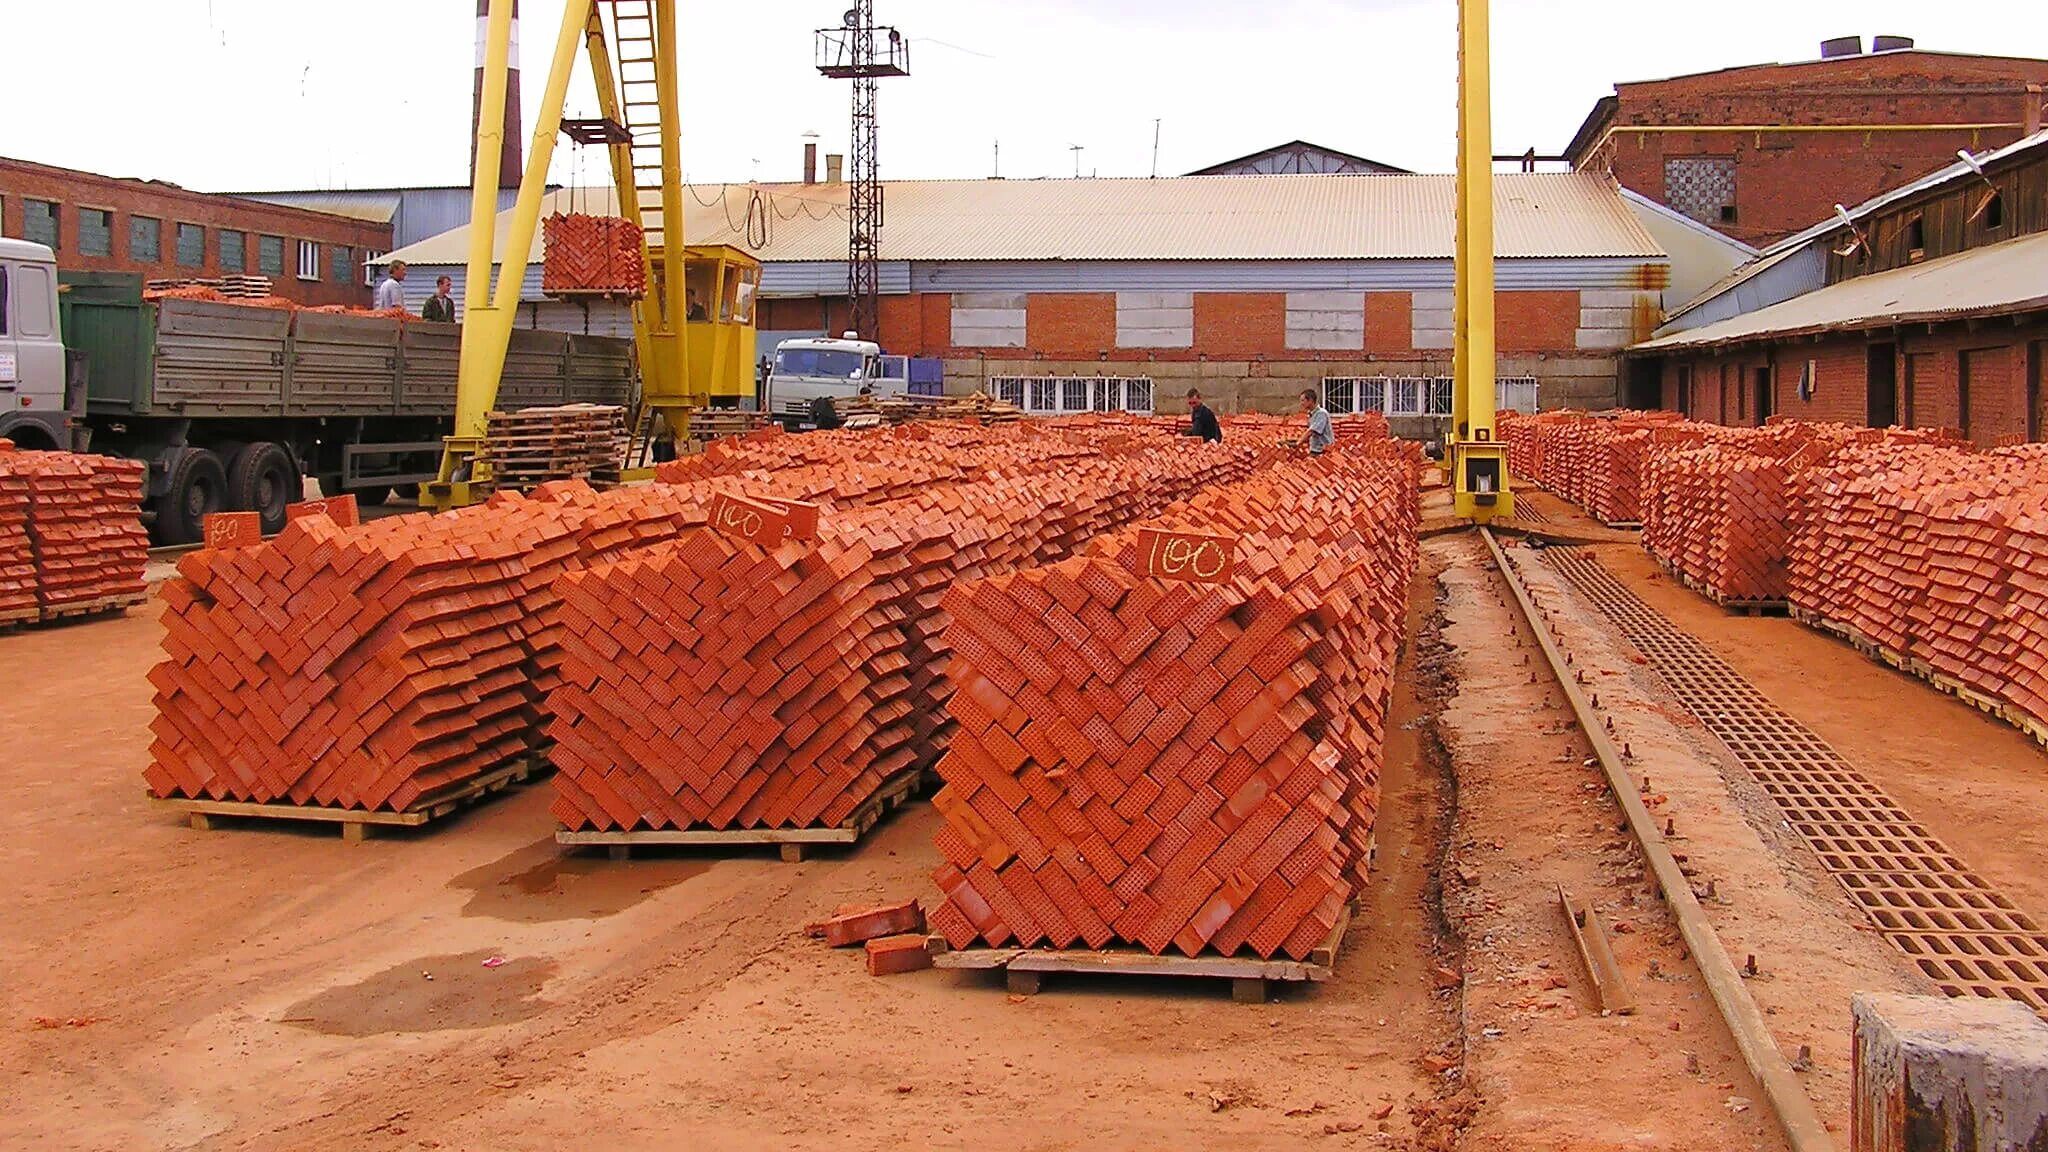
[0,487,2048,1152]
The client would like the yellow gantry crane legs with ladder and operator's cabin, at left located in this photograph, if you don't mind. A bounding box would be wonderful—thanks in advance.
[420,0,760,508]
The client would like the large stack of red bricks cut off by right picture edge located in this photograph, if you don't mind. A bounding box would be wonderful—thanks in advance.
[1790,441,2048,744]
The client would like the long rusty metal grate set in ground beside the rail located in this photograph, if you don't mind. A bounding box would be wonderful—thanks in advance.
[1546,547,2048,1015]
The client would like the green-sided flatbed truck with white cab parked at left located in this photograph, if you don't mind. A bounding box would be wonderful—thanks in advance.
[0,240,637,543]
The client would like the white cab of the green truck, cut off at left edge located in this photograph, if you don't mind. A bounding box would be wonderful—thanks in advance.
[0,238,76,449]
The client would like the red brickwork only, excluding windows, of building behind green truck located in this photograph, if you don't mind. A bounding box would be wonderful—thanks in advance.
[0,158,391,305]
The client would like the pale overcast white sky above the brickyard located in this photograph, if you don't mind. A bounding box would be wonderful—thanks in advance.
[0,0,2048,191]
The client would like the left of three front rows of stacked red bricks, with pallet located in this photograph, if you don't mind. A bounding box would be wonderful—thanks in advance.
[145,416,1294,838]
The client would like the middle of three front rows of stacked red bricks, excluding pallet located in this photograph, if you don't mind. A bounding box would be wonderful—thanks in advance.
[551,437,1253,830]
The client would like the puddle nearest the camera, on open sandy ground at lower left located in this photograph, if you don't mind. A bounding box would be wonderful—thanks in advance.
[281,951,555,1037]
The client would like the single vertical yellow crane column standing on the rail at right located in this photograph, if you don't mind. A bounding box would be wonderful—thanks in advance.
[1444,0,1516,523]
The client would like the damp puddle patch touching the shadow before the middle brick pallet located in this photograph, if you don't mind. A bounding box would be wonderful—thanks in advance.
[449,836,717,924]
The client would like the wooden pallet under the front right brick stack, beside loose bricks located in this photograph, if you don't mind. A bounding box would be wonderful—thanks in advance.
[926,906,1352,1004]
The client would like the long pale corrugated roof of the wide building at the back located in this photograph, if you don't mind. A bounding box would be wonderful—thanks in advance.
[385,172,1665,264]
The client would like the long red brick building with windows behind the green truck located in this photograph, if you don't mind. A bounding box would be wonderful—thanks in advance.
[0,158,391,305]
